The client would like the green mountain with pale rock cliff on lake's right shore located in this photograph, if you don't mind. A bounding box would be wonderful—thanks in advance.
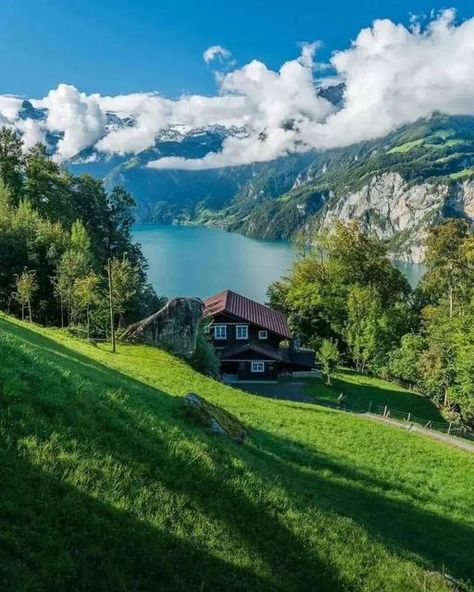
[216,114,474,261]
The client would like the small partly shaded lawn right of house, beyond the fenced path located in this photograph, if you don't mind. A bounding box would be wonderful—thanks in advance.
[307,369,445,422]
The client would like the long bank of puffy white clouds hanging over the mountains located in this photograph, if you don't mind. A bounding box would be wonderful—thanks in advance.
[0,10,474,169]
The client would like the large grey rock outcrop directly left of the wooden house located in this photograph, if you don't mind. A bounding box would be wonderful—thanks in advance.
[120,298,204,359]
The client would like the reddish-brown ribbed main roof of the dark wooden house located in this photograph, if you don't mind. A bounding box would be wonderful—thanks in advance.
[204,290,290,339]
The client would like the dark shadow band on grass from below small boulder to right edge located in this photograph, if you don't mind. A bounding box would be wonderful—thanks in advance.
[244,431,474,582]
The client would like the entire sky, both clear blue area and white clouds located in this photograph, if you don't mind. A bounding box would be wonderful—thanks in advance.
[0,0,474,170]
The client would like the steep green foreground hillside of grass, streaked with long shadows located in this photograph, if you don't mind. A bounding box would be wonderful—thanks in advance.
[0,318,474,592]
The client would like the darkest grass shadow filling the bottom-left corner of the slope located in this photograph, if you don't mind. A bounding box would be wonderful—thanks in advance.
[0,439,271,592]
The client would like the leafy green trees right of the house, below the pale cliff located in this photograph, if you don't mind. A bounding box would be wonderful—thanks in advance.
[268,219,474,425]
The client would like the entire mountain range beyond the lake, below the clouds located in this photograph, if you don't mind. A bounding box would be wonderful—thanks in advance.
[12,95,474,261]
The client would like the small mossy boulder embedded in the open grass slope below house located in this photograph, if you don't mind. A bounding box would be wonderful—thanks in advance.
[183,393,247,444]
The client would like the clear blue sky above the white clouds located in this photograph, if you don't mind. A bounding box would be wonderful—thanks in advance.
[0,0,474,97]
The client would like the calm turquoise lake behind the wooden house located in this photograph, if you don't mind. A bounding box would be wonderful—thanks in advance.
[133,224,423,302]
